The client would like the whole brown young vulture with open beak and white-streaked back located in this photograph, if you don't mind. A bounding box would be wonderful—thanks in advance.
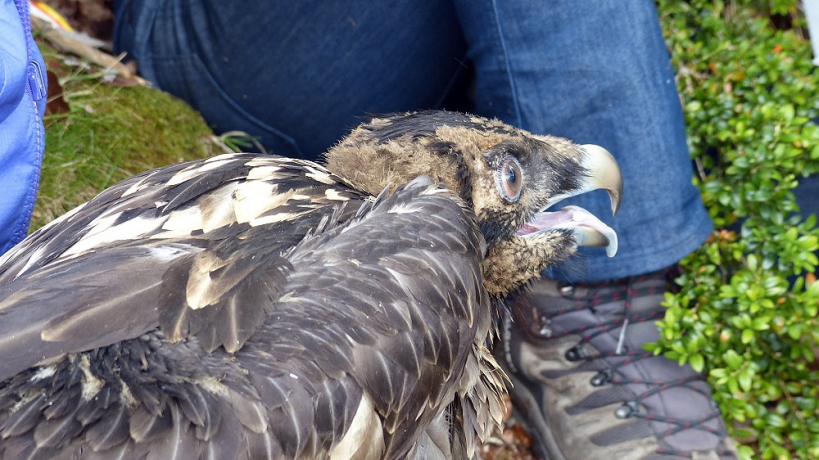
[0,112,622,460]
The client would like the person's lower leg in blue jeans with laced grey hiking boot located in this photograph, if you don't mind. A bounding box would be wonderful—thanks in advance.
[455,0,735,459]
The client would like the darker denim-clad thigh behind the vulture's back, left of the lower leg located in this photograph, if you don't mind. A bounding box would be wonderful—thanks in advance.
[114,0,466,158]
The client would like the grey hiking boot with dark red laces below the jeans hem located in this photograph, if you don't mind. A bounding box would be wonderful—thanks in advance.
[497,270,738,460]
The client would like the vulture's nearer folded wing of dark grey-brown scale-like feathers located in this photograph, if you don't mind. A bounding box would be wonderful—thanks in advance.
[0,176,490,459]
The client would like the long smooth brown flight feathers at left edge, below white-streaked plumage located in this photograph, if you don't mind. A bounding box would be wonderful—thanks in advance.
[0,247,194,379]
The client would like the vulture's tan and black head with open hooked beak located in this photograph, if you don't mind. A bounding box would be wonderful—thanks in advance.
[326,111,623,297]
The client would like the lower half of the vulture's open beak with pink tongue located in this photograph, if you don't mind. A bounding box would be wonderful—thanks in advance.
[517,206,617,257]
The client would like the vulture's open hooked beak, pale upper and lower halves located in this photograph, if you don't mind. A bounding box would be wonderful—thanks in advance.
[517,144,623,257]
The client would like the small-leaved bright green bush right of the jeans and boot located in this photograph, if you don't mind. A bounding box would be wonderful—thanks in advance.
[649,0,819,459]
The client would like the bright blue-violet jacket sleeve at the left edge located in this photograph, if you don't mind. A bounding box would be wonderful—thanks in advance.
[0,0,47,254]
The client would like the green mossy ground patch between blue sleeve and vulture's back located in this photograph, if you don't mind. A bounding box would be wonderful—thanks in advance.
[31,44,214,230]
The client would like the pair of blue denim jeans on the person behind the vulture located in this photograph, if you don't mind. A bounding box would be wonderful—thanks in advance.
[114,0,711,281]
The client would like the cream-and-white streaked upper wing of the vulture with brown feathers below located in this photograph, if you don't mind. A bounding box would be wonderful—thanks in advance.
[0,154,363,379]
